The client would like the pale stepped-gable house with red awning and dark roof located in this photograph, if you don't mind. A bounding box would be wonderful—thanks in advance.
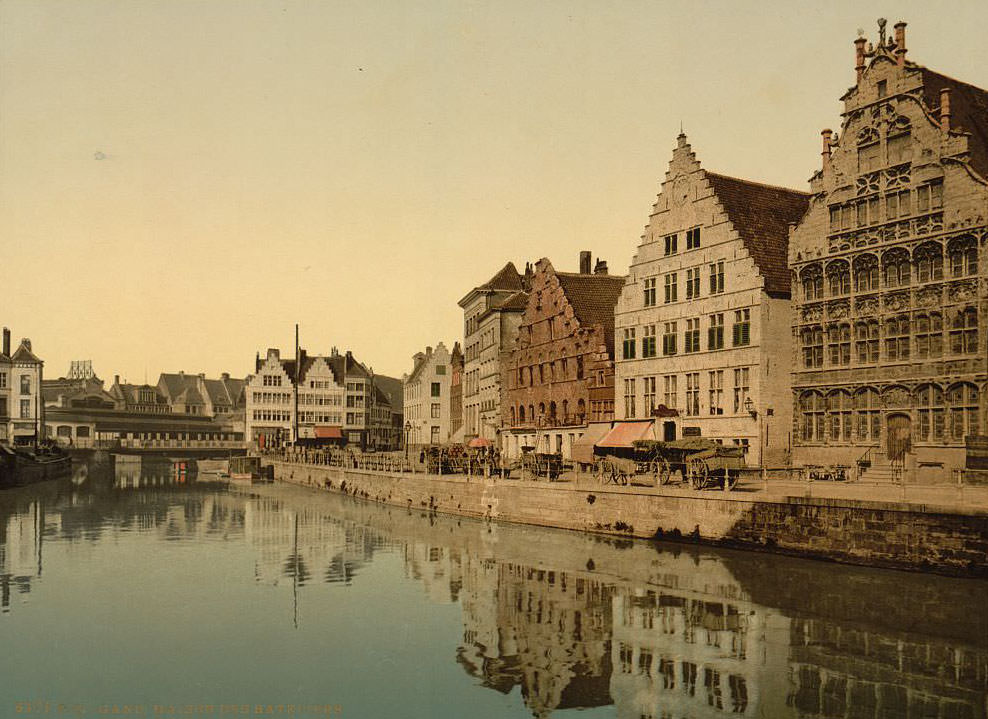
[614,135,808,465]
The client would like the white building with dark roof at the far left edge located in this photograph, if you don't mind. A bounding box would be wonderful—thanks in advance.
[0,327,44,444]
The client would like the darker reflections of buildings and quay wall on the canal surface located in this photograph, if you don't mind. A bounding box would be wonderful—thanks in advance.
[0,466,988,719]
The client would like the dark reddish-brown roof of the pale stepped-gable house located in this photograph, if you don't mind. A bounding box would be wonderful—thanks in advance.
[706,172,809,297]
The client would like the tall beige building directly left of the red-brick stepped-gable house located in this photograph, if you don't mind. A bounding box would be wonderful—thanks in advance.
[459,262,531,440]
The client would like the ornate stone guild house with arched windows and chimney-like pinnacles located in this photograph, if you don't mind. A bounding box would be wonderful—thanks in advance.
[789,20,988,478]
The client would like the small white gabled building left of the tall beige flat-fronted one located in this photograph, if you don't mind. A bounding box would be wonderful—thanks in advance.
[402,342,453,445]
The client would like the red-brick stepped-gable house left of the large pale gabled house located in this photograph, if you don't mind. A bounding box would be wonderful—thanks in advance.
[501,252,625,459]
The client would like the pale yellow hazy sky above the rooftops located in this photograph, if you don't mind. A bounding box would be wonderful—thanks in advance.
[0,0,988,383]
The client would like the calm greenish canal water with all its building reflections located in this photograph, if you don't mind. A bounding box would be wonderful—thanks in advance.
[0,464,988,719]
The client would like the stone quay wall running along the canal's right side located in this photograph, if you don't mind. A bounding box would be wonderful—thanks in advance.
[265,459,988,577]
